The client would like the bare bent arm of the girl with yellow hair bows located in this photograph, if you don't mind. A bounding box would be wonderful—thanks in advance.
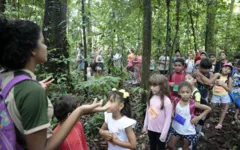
[111,126,137,149]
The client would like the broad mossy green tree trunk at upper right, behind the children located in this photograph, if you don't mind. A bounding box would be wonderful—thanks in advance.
[205,0,217,53]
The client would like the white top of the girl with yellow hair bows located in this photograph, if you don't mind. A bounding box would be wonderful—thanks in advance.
[104,112,136,150]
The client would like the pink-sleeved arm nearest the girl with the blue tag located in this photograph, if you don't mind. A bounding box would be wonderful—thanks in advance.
[159,104,173,142]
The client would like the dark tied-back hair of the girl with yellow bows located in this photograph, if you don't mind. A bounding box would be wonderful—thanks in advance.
[108,91,132,118]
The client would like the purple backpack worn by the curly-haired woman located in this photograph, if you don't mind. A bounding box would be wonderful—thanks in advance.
[0,75,32,150]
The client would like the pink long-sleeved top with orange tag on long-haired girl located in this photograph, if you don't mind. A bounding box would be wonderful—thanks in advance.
[144,95,173,141]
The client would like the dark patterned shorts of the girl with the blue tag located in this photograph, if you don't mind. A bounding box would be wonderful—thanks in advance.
[168,127,200,145]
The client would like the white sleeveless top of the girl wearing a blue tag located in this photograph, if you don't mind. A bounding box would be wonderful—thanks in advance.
[172,103,196,135]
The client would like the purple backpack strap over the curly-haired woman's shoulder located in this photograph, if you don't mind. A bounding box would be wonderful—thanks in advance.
[1,75,32,99]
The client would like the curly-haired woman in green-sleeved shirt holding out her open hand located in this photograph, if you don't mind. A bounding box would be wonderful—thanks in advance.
[0,18,107,150]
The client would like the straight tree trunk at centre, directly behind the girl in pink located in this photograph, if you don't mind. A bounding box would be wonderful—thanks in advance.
[142,0,152,90]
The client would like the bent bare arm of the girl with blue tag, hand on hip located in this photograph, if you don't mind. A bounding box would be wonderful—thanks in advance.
[191,103,211,124]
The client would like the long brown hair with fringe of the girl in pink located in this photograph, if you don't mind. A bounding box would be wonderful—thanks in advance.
[148,74,170,110]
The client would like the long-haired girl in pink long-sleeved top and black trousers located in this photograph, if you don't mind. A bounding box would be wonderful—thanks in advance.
[143,74,173,150]
